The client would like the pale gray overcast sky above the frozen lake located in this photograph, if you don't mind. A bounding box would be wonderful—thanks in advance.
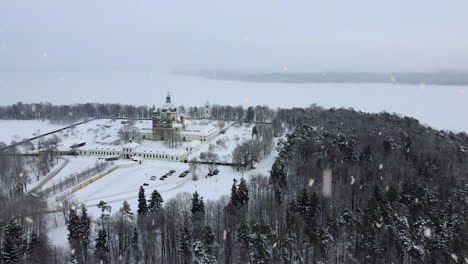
[0,0,468,71]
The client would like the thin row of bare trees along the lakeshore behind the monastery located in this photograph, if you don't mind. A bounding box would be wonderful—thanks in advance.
[0,102,275,124]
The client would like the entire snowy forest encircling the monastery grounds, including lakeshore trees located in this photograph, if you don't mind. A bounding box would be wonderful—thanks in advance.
[0,103,468,264]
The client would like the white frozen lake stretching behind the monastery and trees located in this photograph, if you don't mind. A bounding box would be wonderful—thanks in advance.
[0,72,468,131]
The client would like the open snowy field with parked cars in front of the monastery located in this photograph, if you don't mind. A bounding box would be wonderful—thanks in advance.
[49,144,277,245]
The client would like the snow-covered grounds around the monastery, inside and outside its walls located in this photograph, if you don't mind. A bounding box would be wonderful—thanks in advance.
[2,114,277,245]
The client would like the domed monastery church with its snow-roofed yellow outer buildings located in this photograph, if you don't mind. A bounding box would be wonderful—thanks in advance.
[58,93,220,162]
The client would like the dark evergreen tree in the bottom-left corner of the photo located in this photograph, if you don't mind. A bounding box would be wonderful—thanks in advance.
[1,222,27,264]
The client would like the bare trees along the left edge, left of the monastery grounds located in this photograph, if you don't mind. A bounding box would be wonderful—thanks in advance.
[0,143,66,264]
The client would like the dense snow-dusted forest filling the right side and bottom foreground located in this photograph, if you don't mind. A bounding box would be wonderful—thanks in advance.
[56,105,468,264]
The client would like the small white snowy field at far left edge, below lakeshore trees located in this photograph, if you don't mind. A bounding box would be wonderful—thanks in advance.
[0,119,65,144]
